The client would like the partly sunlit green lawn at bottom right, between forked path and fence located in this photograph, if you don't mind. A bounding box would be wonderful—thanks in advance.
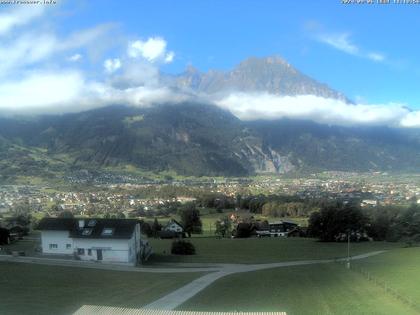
[178,263,420,315]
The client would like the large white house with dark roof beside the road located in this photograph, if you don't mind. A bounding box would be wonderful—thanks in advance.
[38,218,151,265]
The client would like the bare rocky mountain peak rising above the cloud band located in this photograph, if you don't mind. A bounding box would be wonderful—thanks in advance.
[164,55,351,103]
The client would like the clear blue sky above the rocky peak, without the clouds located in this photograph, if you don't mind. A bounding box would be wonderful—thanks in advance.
[56,0,420,108]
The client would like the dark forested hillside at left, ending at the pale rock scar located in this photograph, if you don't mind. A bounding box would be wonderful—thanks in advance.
[0,103,296,180]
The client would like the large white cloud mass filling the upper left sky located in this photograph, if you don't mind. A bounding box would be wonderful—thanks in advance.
[0,2,185,113]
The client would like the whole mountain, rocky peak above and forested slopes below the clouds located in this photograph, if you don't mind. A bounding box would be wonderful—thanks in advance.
[0,57,420,181]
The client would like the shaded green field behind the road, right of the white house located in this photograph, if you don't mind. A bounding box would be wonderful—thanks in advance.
[149,237,401,263]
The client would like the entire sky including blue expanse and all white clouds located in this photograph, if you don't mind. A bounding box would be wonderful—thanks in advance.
[0,0,420,127]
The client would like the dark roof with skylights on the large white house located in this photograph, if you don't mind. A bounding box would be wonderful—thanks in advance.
[38,218,139,239]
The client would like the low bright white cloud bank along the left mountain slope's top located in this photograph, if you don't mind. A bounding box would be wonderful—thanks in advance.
[0,71,187,114]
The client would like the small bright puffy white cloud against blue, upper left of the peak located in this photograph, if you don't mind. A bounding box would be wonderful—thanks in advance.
[127,37,175,63]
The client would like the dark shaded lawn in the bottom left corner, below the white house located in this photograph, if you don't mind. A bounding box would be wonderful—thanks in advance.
[0,263,200,315]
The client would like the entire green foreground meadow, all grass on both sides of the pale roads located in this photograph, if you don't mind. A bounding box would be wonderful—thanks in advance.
[0,225,420,315]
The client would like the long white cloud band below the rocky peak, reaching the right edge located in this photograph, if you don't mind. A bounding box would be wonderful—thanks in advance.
[216,93,420,127]
